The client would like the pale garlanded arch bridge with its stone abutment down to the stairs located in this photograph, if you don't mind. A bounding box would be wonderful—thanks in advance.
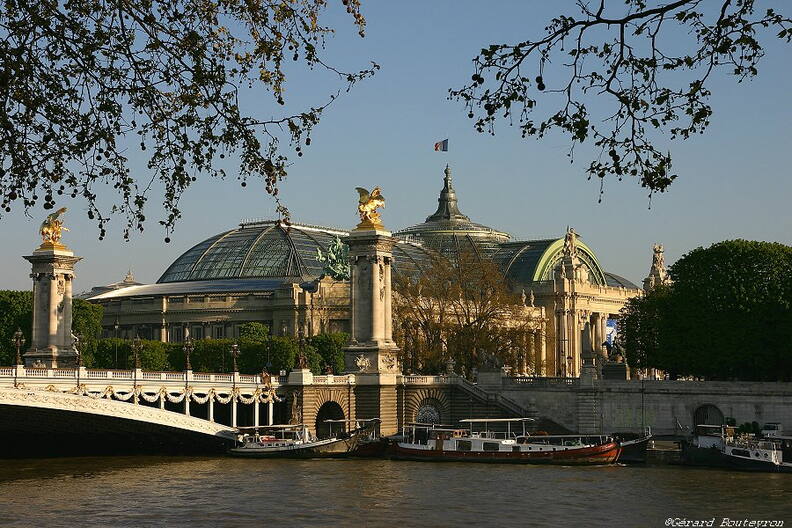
[0,365,527,456]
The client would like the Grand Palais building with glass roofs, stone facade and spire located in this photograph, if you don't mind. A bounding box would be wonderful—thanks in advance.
[87,168,642,376]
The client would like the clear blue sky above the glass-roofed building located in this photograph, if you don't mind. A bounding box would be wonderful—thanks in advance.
[0,0,792,291]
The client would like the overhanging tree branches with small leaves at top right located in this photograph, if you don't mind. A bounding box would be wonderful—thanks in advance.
[449,0,792,197]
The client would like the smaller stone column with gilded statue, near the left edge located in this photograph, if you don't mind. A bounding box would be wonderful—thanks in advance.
[24,207,81,368]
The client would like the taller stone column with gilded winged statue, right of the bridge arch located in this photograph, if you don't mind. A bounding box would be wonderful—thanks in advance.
[344,187,400,435]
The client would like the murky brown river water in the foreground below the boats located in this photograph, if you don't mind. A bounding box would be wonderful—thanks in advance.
[0,457,792,528]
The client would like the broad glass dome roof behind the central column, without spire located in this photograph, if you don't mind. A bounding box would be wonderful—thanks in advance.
[157,221,429,283]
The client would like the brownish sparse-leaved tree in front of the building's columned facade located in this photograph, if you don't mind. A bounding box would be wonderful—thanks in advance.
[393,251,537,375]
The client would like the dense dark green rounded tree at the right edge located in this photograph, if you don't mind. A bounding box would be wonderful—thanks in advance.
[619,240,792,381]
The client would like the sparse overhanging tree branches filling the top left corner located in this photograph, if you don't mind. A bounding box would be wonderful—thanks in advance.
[0,0,378,242]
